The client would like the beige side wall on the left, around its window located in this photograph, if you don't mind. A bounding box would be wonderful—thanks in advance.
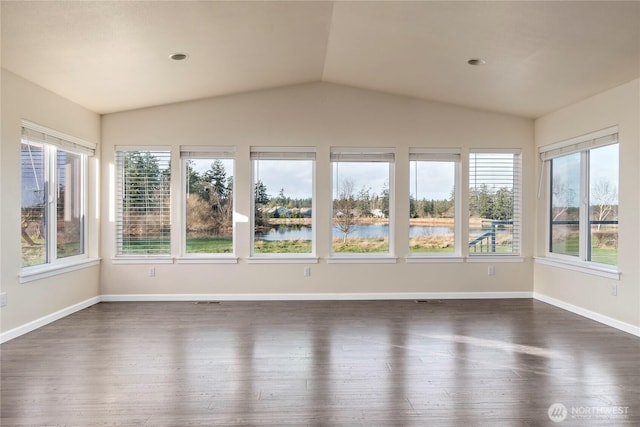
[0,69,100,332]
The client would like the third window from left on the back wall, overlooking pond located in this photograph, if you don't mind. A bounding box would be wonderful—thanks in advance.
[251,147,316,255]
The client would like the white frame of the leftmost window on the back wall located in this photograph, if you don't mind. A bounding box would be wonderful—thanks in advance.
[112,145,175,264]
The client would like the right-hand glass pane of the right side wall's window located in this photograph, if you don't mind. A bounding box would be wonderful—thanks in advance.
[588,144,619,265]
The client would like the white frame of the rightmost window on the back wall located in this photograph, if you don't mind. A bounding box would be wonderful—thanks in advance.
[464,148,524,262]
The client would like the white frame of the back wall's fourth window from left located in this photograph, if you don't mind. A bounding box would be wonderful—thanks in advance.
[327,147,398,264]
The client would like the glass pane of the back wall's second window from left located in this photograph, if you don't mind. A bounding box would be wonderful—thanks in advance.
[185,159,233,254]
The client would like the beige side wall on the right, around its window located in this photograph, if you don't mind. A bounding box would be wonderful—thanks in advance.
[534,80,640,326]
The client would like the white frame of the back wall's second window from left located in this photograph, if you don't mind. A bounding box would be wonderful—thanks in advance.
[175,145,238,264]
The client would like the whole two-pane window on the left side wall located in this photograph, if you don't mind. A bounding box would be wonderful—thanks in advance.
[21,123,95,267]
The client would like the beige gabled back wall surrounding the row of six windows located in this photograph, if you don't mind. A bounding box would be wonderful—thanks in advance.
[101,83,536,294]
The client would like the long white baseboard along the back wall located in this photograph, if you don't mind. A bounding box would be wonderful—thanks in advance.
[100,292,533,302]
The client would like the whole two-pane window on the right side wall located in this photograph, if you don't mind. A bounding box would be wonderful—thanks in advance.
[541,129,619,265]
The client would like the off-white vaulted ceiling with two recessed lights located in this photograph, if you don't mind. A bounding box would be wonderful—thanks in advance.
[1,1,640,117]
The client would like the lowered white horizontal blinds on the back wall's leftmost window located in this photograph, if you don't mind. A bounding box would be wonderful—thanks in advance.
[116,149,171,256]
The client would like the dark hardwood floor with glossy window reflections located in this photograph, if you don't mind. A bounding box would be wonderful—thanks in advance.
[0,300,640,427]
